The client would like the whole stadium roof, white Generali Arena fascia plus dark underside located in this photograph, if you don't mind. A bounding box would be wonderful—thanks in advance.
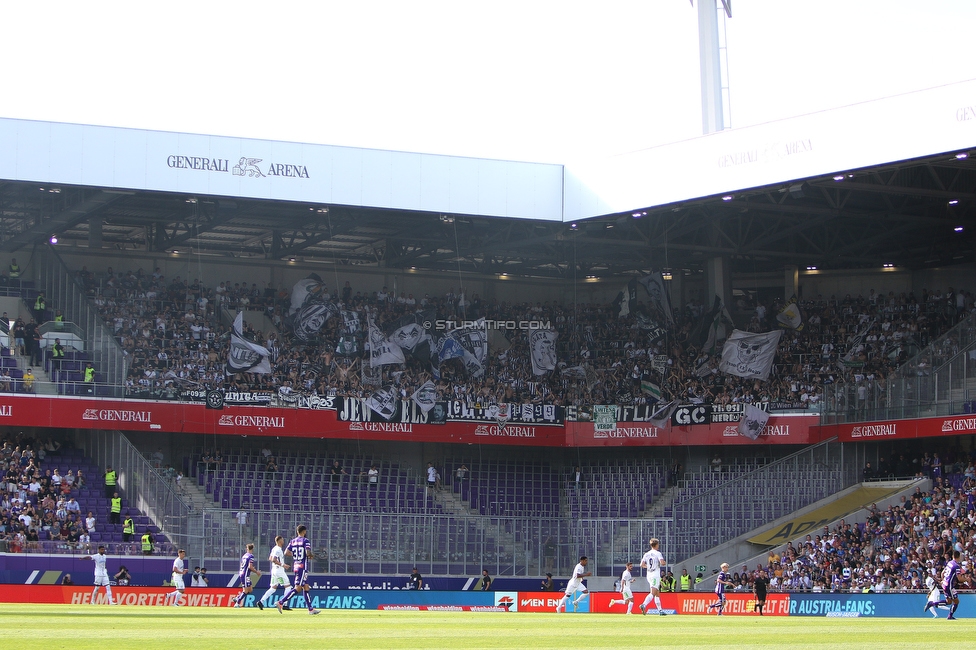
[0,80,976,279]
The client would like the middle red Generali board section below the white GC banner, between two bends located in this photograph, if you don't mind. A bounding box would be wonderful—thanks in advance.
[566,415,822,447]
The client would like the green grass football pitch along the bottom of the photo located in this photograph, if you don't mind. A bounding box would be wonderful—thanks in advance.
[0,604,976,650]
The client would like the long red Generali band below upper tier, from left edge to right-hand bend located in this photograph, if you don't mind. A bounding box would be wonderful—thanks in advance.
[0,395,821,447]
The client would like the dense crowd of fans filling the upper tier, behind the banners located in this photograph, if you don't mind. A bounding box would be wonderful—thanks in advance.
[72,269,974,408]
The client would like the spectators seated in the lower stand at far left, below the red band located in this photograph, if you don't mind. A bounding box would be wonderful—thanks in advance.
[0,435,96,552]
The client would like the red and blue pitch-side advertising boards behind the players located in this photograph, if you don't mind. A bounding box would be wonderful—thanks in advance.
[0,585,960,618]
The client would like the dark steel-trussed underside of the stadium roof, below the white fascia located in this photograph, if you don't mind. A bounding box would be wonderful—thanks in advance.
[0,151,976,277]
